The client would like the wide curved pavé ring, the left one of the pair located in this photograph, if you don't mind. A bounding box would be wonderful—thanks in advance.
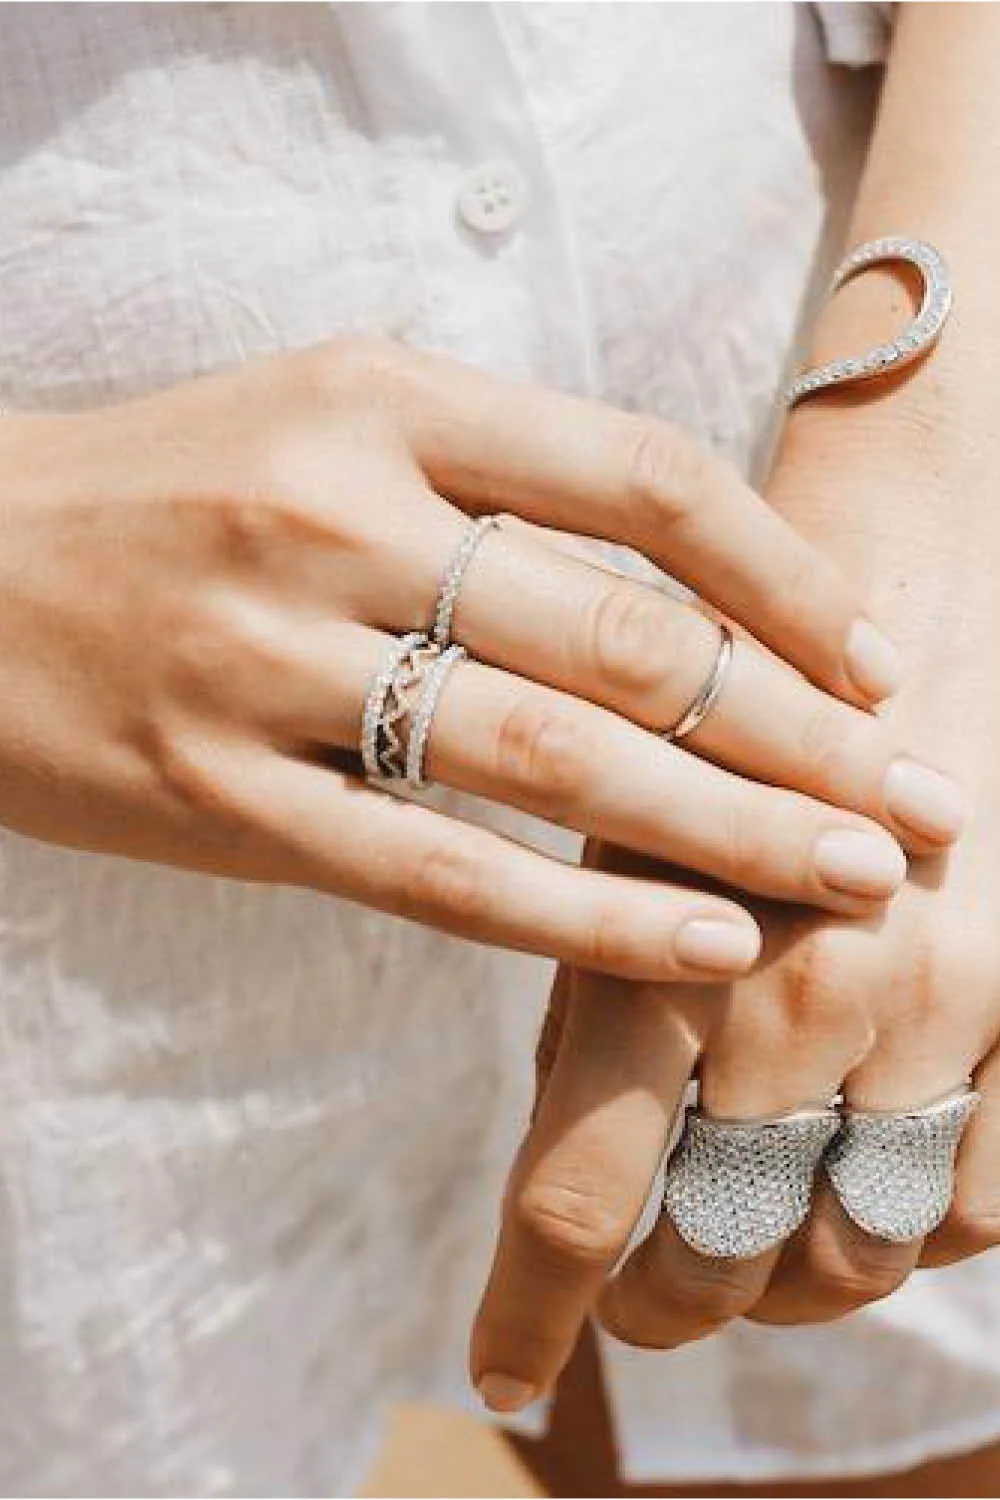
[663,1109,840,1260]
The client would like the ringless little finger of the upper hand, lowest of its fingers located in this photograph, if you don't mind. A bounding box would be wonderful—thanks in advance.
[236,752,760,983]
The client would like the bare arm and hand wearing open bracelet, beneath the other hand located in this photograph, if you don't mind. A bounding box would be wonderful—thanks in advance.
[472,5,1000,1434]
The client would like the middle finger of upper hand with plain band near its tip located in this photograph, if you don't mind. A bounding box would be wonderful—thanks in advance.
[440,518,963,851]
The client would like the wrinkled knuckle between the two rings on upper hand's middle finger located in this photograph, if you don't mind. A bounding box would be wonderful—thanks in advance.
[585,585,675,698]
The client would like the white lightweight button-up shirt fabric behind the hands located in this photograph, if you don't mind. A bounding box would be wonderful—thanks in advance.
[0,3,1000,1496]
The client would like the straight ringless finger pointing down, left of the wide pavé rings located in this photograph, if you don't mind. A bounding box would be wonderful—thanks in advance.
[471,971,712,1412]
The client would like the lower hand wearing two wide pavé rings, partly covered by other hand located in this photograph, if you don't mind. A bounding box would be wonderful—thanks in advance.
[472,390,1000,1410]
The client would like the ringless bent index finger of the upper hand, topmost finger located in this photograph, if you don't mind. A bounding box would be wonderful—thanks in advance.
[403,354,900,705]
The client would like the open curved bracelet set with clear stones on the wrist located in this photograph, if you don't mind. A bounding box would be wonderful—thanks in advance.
[784,234,955,407]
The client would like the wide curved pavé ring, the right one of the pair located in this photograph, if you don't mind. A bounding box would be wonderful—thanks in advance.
[825,1086,979,1244]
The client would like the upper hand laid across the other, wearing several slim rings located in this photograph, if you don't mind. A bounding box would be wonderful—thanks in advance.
[0,341,936,980]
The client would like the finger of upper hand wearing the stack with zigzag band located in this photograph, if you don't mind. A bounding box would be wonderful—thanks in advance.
[285,615,906,914]
